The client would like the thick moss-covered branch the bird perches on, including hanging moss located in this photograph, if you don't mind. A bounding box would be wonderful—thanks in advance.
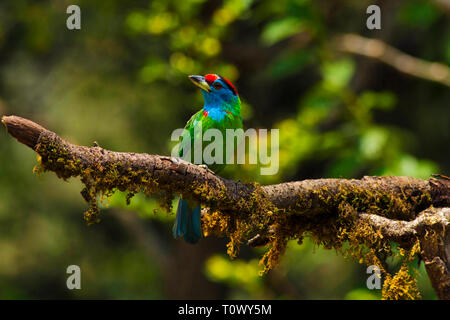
[2,116,450,299]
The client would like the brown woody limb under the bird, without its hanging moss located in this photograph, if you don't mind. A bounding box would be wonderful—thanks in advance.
[2,116,450,214]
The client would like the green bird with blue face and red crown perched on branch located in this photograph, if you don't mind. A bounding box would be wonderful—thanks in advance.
[172,74,243,244]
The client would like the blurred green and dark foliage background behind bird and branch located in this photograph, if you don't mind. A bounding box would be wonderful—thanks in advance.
[0,0,450,299]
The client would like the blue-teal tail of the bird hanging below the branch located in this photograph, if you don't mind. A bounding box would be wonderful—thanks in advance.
[173,197,202,243]
